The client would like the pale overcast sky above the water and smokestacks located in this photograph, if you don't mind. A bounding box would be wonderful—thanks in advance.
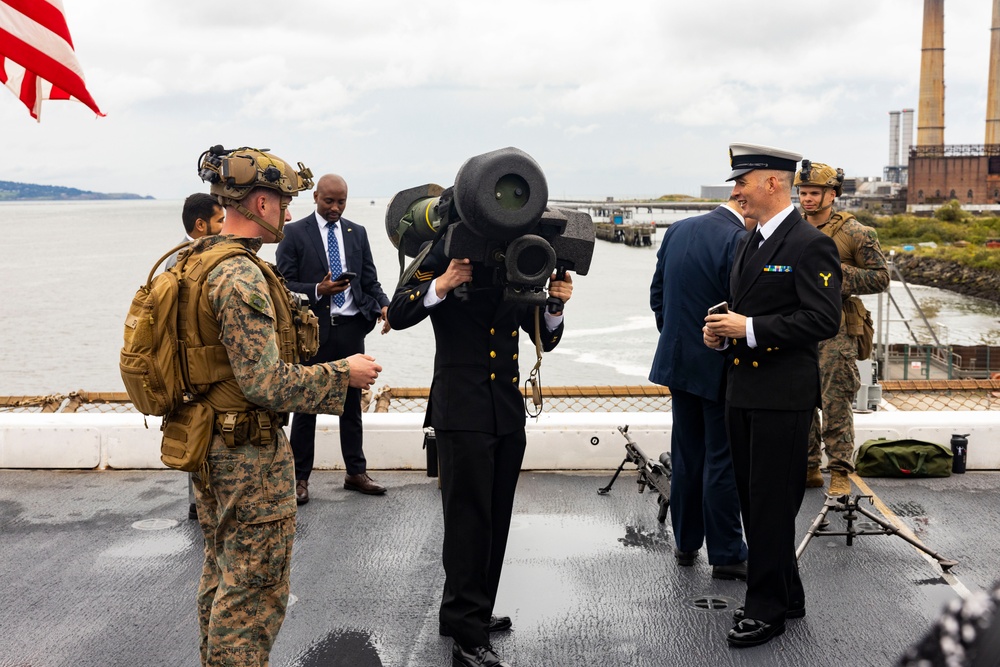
[0,0,992,198]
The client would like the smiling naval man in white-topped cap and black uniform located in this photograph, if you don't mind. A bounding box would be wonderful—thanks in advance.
[703,144,841,647]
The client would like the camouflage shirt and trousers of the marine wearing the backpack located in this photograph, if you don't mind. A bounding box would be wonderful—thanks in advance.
[192,236,350,667]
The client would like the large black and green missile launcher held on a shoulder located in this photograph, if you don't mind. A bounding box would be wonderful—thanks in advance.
[385,148,594,312]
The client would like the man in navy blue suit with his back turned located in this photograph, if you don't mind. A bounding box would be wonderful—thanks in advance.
[649,199,747,579]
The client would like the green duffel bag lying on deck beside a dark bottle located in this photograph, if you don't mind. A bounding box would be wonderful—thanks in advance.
[854,438,952,477]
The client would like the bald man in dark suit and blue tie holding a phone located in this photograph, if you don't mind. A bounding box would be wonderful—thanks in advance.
[277,174,389,505]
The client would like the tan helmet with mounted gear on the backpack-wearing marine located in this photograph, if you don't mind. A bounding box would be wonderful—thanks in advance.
[198,146,313,202]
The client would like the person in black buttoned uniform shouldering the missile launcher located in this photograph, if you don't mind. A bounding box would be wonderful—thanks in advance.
[389,243,573,667]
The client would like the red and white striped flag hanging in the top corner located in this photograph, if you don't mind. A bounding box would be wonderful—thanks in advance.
[0,0,104,120]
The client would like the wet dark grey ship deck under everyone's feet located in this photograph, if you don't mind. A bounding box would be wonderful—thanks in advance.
[0,470,1000,667]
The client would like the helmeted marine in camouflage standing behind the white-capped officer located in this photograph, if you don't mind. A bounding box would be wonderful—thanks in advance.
[795,160,889,497]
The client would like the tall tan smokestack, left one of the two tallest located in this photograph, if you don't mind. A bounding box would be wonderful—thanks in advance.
[917,0,944,147]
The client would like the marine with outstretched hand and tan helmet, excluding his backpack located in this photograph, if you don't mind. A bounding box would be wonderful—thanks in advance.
[189,149,380,667]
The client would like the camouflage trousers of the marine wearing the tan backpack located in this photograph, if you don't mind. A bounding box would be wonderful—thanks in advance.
[189,429,295,667]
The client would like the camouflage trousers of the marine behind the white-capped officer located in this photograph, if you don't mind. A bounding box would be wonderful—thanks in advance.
[808,323,861,472]
